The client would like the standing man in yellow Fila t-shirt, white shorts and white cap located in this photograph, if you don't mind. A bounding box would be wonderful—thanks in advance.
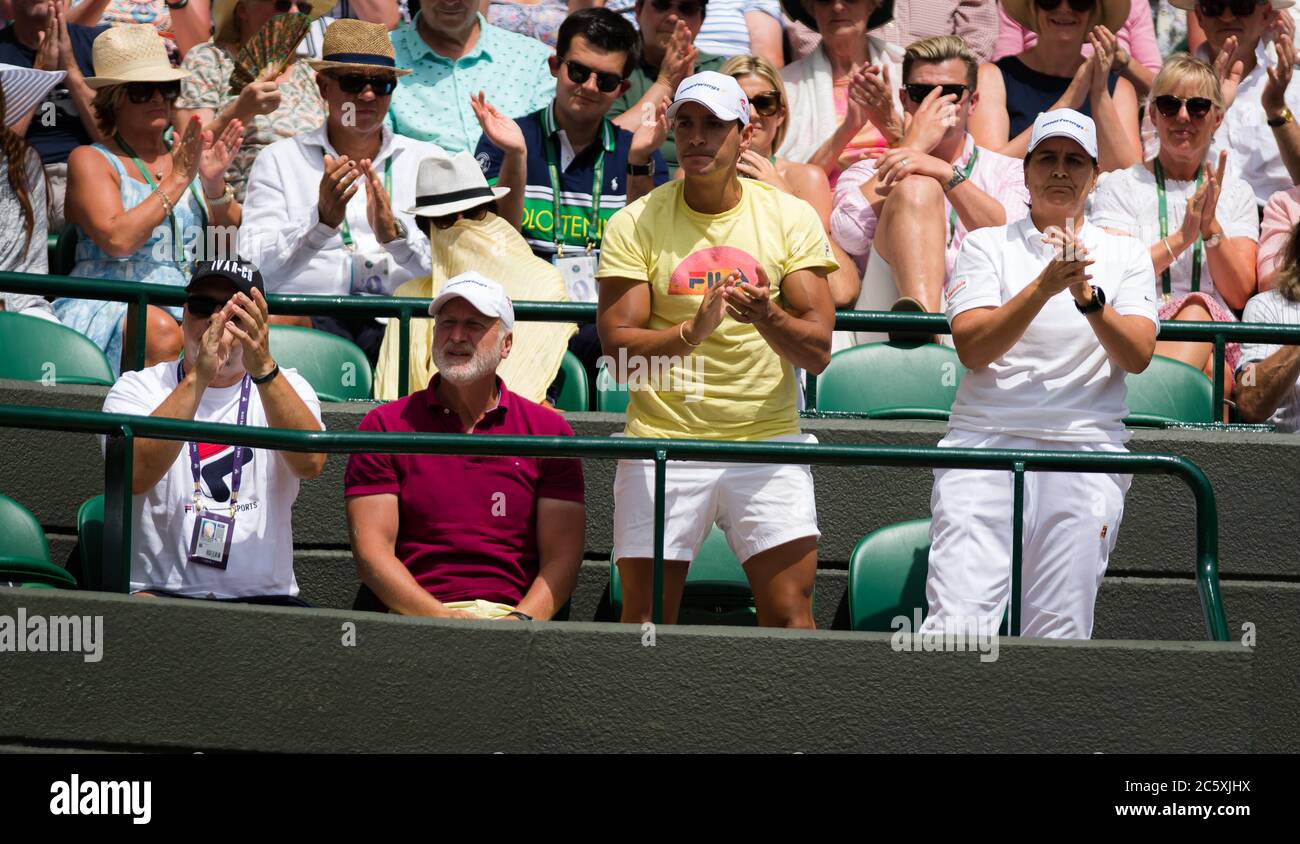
[597,70,837,628]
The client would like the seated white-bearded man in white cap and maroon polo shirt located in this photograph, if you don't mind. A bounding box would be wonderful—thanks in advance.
[343,273,586,620]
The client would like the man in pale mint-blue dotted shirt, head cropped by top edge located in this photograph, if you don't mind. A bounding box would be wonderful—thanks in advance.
[389,0,555,153]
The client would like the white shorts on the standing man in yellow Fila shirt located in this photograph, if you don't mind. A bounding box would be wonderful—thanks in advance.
[614,434,822,564]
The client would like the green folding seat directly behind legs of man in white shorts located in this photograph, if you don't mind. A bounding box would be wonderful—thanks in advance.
[610,525,758,627]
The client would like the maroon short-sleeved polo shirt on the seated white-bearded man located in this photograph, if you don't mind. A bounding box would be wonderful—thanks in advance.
[343,375,582,606]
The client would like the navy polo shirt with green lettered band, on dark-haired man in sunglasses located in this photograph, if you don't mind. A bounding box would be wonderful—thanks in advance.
[475,101,668,260]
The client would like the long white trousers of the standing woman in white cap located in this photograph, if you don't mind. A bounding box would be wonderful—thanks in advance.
[922,430,1132,639]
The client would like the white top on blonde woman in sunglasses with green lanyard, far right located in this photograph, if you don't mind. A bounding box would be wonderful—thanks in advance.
[1088,164,1260,311]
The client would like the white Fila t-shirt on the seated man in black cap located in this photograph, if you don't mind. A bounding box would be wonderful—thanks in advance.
[100,362,324,598]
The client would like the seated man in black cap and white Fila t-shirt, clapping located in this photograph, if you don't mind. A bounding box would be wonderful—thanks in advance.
[104,261,325,605]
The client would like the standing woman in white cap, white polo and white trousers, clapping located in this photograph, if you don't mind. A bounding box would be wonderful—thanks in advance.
[923,109,1158,639]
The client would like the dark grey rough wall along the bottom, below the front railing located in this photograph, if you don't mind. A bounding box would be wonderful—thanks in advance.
[0,589,1263,753]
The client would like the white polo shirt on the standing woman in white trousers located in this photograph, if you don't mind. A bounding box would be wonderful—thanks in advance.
[944,217,1160,442]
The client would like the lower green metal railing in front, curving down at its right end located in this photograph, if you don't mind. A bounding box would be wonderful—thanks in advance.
[0,404,1229,641]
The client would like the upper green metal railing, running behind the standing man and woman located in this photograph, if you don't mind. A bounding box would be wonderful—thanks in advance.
[0,267,1300,420]
